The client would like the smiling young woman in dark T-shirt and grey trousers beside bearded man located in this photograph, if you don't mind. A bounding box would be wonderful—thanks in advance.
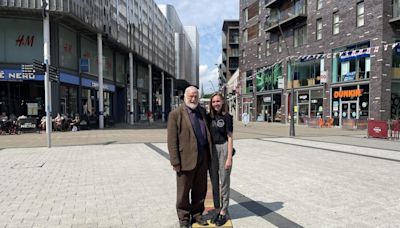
[208,93,233,226]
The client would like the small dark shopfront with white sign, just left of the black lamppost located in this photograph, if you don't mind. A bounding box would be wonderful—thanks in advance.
[257,91,282,122]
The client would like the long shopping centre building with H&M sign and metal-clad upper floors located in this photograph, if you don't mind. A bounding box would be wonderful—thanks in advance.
[0,0,198,124]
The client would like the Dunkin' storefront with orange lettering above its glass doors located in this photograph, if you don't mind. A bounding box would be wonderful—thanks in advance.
[331,84,370,128]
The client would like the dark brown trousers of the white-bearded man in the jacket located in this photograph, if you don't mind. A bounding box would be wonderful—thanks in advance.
[176,150,208,223]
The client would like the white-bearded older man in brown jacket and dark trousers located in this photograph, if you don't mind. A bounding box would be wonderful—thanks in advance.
[167,86,211,227]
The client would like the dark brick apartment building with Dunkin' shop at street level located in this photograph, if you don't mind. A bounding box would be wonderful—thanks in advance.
[240,0,400,129]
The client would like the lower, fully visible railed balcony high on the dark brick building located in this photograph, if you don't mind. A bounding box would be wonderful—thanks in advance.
[264,4,307,32]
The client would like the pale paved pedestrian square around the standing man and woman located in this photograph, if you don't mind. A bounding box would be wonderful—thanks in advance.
[0,133,400,228]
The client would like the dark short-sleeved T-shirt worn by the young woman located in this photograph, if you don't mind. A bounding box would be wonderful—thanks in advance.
[208,113,233,144]
